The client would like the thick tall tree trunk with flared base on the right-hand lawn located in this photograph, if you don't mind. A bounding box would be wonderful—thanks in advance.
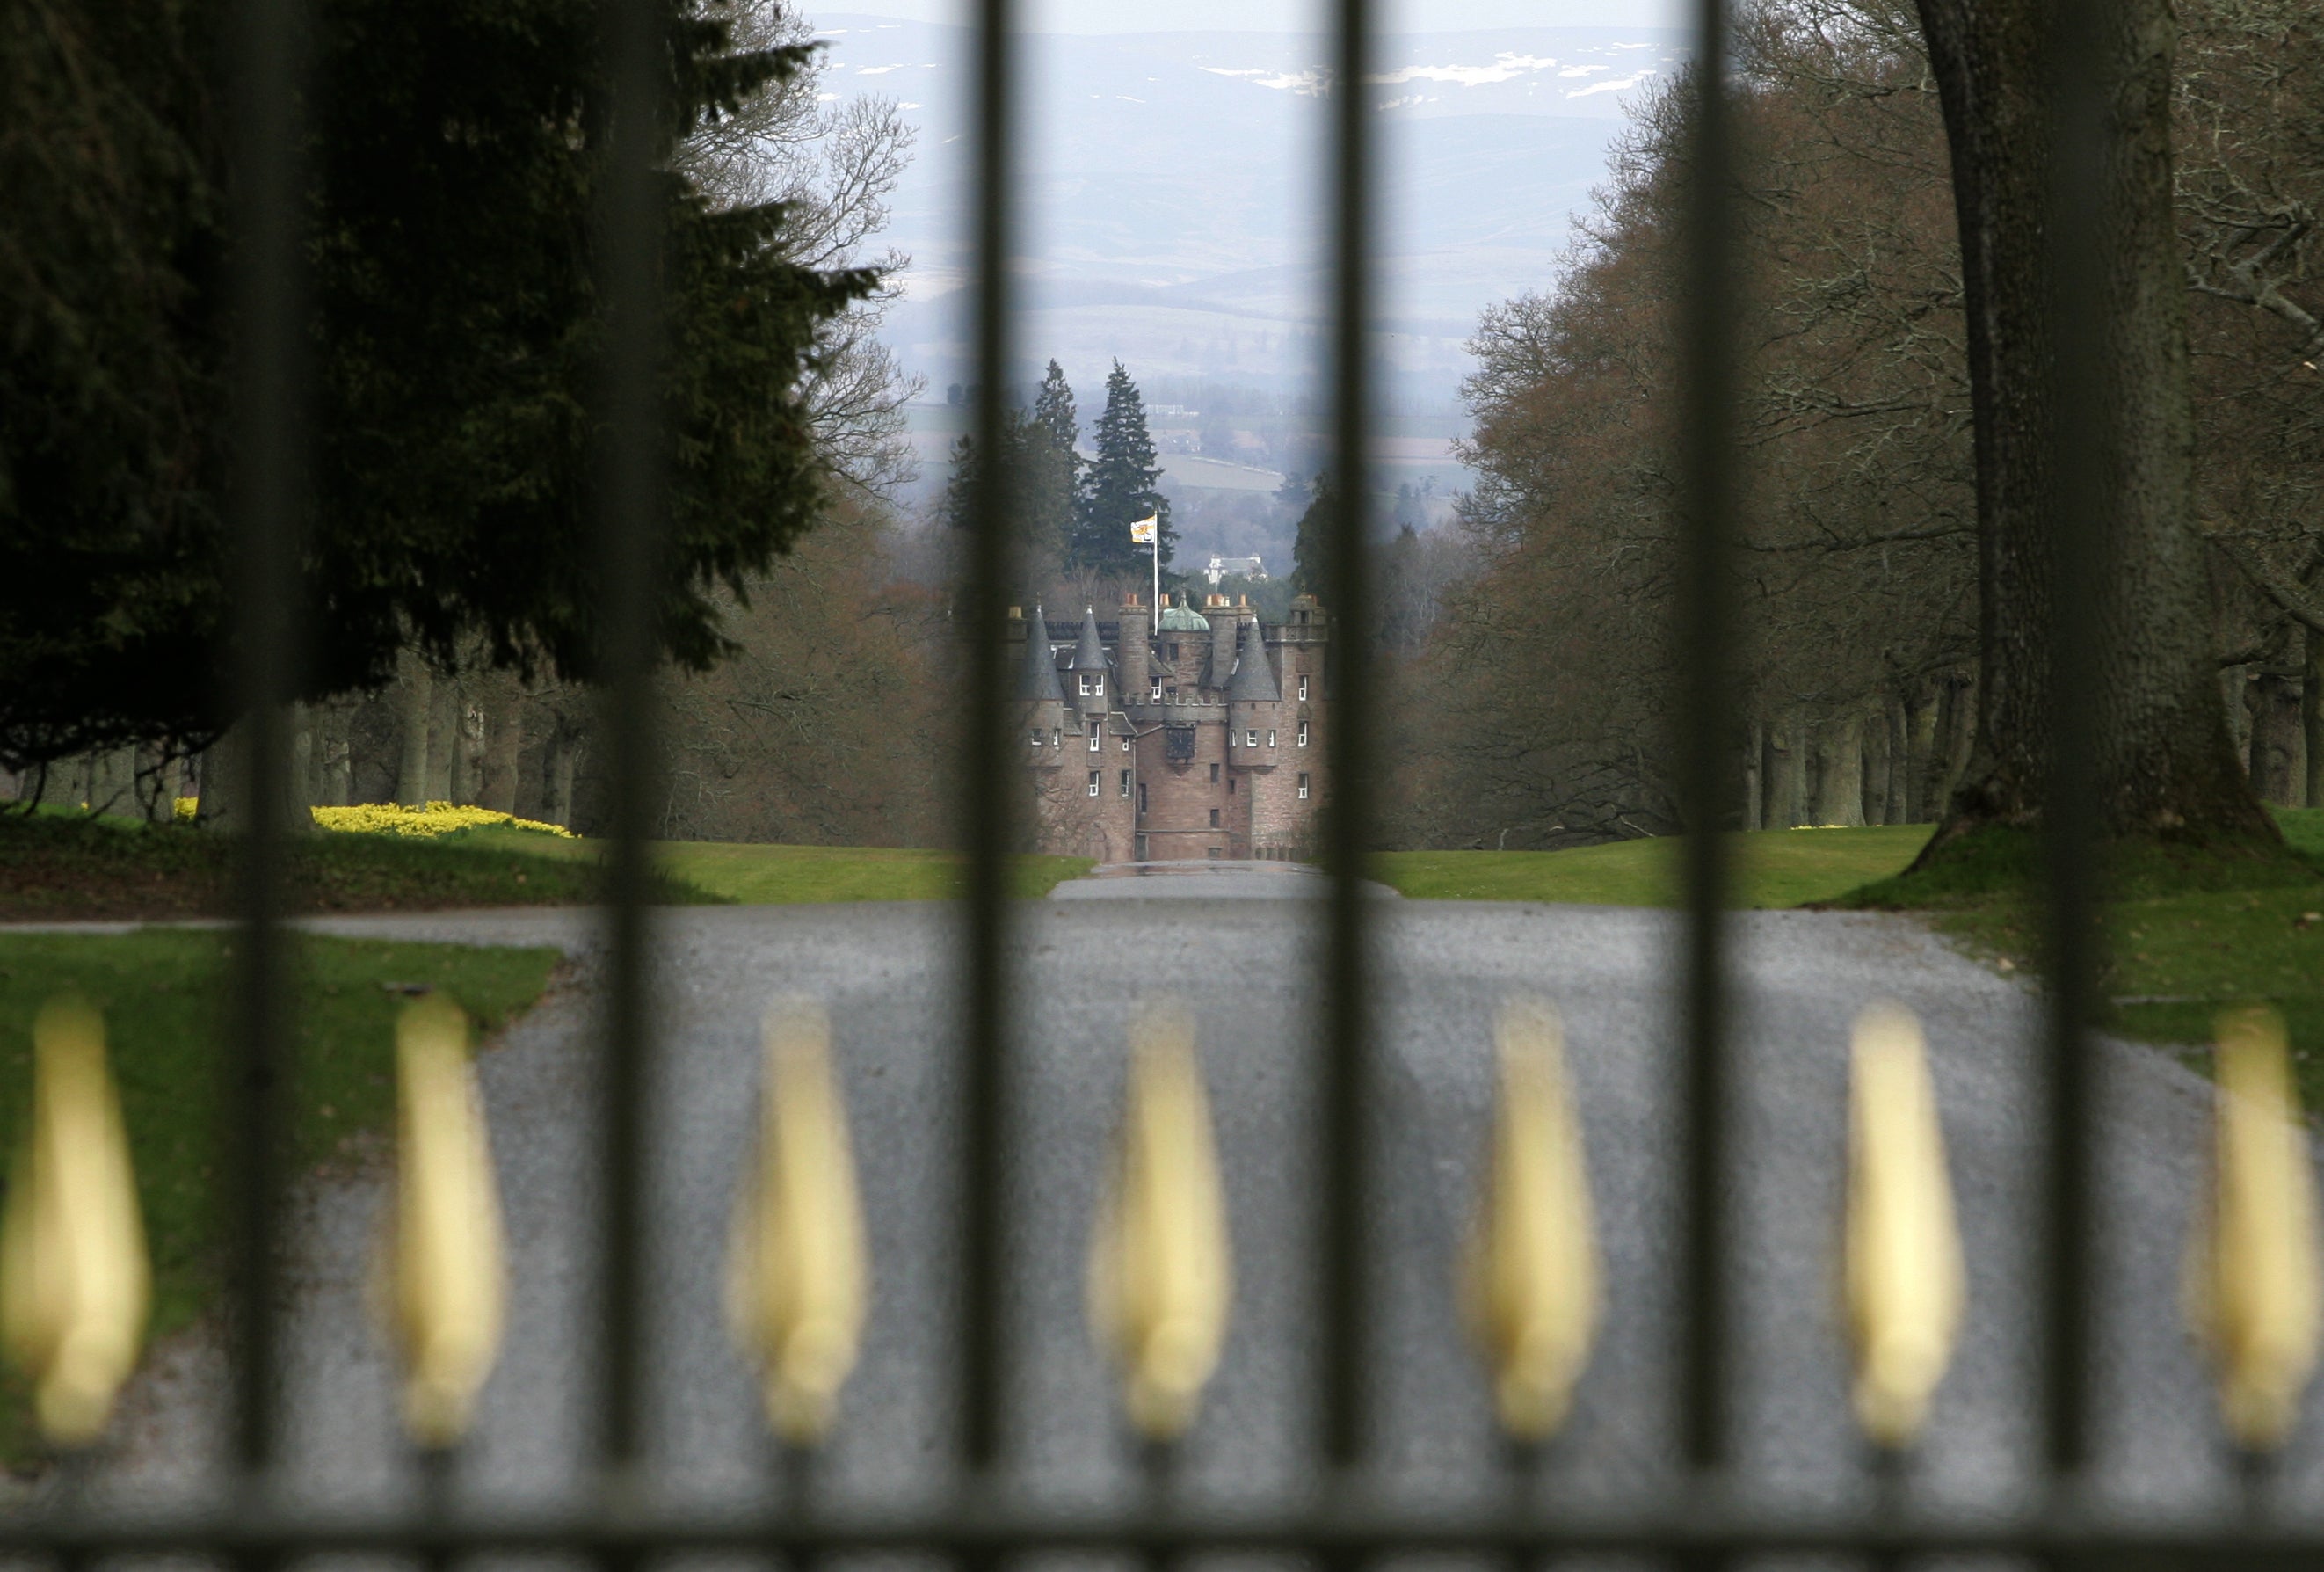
[1920,0,2275,858]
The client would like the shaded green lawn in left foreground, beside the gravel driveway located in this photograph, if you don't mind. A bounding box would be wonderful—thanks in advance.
[0,930,558,1465]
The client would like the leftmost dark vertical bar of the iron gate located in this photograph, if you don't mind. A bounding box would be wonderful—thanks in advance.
[221,0,307,1486]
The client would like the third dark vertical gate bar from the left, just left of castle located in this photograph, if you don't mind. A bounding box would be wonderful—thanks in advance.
[957,0,1015,1486]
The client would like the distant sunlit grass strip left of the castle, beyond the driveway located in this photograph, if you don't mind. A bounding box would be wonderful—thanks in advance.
[441,826,1094,905]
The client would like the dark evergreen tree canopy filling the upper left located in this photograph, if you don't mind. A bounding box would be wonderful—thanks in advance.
[0,0,876,765]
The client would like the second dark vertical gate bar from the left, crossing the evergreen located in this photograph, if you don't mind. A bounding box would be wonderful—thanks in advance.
[598,0,665,1470]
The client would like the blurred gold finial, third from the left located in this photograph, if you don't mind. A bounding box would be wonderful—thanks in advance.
[728,998,872,1446]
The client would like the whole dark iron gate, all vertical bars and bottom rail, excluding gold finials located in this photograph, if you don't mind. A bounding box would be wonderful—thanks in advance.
[0,0,2324,1568]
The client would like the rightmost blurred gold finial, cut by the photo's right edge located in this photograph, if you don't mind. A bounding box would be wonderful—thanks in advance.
[2184,1007,2324,1451]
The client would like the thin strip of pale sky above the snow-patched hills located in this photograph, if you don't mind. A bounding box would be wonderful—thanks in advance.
[836,0,1689,33]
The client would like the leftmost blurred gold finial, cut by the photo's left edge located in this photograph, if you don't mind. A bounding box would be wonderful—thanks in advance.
[0,995,154,1446]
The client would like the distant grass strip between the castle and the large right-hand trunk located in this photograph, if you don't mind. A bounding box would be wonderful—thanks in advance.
[1374,823,1931,907]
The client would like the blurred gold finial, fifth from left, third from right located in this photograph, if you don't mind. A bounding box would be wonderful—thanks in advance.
[1462,998,1599,1442]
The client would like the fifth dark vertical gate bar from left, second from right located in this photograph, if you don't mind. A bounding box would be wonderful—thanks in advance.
[1675,0,1743,1470]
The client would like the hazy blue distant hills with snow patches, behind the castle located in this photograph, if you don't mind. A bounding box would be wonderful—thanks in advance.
[816,14,1685,403]
